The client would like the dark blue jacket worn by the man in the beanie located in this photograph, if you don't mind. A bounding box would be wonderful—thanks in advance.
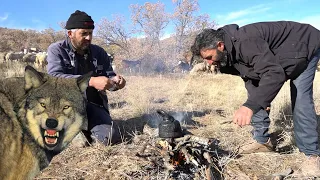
[47,39,116,109]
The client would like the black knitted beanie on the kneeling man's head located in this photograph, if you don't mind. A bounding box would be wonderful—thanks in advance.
[66,10,94,30]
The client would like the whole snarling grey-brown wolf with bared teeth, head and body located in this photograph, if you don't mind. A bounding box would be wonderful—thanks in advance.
[0,66,90,180]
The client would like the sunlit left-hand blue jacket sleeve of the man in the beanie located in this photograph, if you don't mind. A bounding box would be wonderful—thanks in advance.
[47,43,80,78]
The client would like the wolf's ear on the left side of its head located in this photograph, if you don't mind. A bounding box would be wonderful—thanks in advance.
[24,65,46,91]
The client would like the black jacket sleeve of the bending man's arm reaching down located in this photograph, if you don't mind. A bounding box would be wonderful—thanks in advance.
[239,38,287,113]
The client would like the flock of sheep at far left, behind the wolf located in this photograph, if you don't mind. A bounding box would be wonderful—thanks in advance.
[0,52,47,68]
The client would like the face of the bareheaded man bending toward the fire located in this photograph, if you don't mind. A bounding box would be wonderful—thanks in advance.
[200,48,227,66]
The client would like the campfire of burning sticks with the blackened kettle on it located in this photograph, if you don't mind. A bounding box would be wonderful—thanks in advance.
[137,111,222,180]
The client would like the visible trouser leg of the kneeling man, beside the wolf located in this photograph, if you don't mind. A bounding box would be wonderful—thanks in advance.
[84,103,121,145]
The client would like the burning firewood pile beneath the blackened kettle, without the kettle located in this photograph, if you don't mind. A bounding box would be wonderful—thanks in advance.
[156,135,220,180]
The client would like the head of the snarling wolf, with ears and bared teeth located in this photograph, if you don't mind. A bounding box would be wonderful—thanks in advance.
[18,66,91,152]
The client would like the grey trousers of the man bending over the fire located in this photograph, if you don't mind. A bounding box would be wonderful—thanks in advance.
[252,49,320,155]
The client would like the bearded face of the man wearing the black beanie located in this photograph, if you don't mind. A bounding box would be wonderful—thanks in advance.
[68,29,93,51]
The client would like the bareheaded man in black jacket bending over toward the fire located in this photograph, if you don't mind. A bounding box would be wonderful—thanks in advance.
[191,21,320,176]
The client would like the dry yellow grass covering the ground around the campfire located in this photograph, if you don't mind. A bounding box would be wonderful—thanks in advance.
[1,61,320,180]
